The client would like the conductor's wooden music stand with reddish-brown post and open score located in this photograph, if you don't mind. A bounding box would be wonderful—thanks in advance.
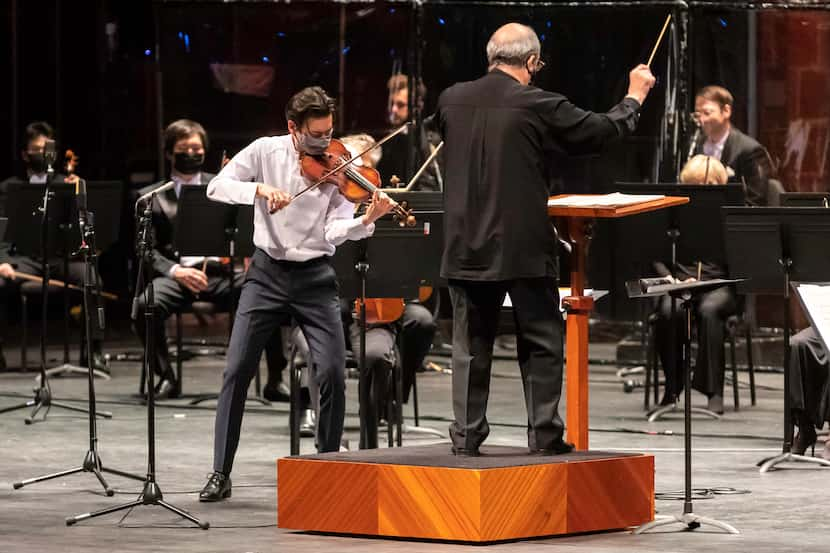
[548,194,689,450]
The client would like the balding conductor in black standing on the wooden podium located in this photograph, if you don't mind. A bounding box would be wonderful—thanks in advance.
[434,23,655,456]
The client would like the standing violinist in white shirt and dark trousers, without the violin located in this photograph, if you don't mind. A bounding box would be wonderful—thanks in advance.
[199,87,394,501]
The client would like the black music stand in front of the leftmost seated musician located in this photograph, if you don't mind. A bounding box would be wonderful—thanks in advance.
[7,181,123,380]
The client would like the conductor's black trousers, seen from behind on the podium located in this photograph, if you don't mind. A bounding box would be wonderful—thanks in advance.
[449,277,564,450]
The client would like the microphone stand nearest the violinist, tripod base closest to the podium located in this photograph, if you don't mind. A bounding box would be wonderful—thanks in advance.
[66,194,210,530]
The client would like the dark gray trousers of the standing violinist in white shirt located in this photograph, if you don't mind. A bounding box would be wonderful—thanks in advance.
[213,250,346,474]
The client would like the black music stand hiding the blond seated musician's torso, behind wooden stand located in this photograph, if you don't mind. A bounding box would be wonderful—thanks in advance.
[616,183,744,422]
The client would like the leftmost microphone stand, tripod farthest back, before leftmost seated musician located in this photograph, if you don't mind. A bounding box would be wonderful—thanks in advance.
[0,160,94,422]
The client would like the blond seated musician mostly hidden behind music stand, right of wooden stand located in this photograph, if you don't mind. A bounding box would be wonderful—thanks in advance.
[655,155,738,414]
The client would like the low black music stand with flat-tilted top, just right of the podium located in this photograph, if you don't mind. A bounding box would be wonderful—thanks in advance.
[626,279,740,534]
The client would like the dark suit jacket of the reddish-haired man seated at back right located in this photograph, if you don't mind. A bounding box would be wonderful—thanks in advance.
[695,127,771,206]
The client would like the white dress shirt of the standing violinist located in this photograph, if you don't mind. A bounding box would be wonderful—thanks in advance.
[207,134,375,261]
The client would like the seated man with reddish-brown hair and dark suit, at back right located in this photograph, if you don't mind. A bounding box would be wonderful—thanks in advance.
[694,85,772,206]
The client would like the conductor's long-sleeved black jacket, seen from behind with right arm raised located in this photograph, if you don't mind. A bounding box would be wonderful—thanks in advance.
[435,70,640,281]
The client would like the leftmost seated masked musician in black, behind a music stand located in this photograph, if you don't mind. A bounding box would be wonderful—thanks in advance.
[0,121,109,372]
